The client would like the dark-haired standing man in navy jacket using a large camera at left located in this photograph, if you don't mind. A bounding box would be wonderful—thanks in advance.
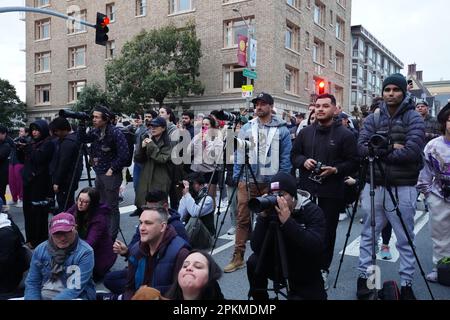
[78,106,129,240]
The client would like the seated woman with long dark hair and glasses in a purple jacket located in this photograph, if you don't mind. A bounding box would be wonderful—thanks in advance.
[67,187,117,282]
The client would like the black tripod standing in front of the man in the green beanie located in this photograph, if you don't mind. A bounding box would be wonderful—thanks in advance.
[334,143,434,300]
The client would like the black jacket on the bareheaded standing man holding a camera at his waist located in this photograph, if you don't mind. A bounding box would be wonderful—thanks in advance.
[291,122,358,199]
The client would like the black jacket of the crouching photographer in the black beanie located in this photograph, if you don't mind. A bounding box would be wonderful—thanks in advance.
[250,195,326,300]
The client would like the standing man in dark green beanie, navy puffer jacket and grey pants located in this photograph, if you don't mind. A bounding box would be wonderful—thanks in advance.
[357,73,425,300]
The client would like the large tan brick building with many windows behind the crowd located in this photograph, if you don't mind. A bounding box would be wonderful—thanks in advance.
[26,0,351,120]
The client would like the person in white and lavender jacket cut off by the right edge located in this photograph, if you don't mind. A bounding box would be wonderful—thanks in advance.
[417,103,450,282]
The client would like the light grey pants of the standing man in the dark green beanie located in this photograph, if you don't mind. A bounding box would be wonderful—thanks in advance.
[358,185,417,286]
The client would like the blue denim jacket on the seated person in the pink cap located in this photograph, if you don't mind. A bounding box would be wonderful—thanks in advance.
[25,239,95,300]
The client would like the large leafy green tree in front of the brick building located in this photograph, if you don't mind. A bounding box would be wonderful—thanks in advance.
[106,24,204,113]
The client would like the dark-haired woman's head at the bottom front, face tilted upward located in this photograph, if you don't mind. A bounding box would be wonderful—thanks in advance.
[165,250,224,300]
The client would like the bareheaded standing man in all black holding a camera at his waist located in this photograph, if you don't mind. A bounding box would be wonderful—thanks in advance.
[291,94,358,289]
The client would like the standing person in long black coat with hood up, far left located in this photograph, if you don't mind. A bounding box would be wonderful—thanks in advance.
[17,120,55,249]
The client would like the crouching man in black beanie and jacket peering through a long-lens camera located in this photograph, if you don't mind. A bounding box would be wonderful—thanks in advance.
[247,172,327,300]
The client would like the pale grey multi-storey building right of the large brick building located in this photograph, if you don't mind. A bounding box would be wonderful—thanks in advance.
[350,25,404,109]
